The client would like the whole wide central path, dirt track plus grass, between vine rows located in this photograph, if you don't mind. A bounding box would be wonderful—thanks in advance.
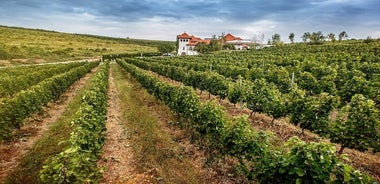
[99,63,226,183]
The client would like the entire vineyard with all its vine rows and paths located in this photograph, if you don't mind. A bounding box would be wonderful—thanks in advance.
[0,42,380,183]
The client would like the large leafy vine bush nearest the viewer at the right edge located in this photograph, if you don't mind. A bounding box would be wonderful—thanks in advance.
[331,94,380,154]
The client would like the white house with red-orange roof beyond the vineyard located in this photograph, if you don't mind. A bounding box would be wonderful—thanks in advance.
[177,33,210,55]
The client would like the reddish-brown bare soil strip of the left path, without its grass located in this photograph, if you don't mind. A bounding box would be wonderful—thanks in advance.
[0,67,98,183]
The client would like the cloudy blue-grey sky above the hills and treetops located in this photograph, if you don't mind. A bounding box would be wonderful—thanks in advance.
[0,0,380,42]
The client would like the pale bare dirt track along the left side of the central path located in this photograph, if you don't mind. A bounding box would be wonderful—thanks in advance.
[98,65,141,183]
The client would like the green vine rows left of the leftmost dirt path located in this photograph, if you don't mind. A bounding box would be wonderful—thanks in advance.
[0,62,99,140]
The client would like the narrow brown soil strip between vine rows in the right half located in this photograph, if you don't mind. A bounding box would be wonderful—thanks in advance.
[145,67,380,182]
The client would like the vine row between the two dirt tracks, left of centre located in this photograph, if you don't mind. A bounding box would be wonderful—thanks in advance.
[40,62,109,183]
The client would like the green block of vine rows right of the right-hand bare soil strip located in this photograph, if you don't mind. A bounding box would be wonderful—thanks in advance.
[117,41,380,153]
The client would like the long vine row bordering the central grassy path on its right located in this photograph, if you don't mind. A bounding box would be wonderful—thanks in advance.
[118,61,371,183]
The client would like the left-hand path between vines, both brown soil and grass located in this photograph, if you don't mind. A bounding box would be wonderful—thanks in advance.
[0,67,98,184]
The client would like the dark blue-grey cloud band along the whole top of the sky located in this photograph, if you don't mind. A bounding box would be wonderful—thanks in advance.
[4,0,380,22]
